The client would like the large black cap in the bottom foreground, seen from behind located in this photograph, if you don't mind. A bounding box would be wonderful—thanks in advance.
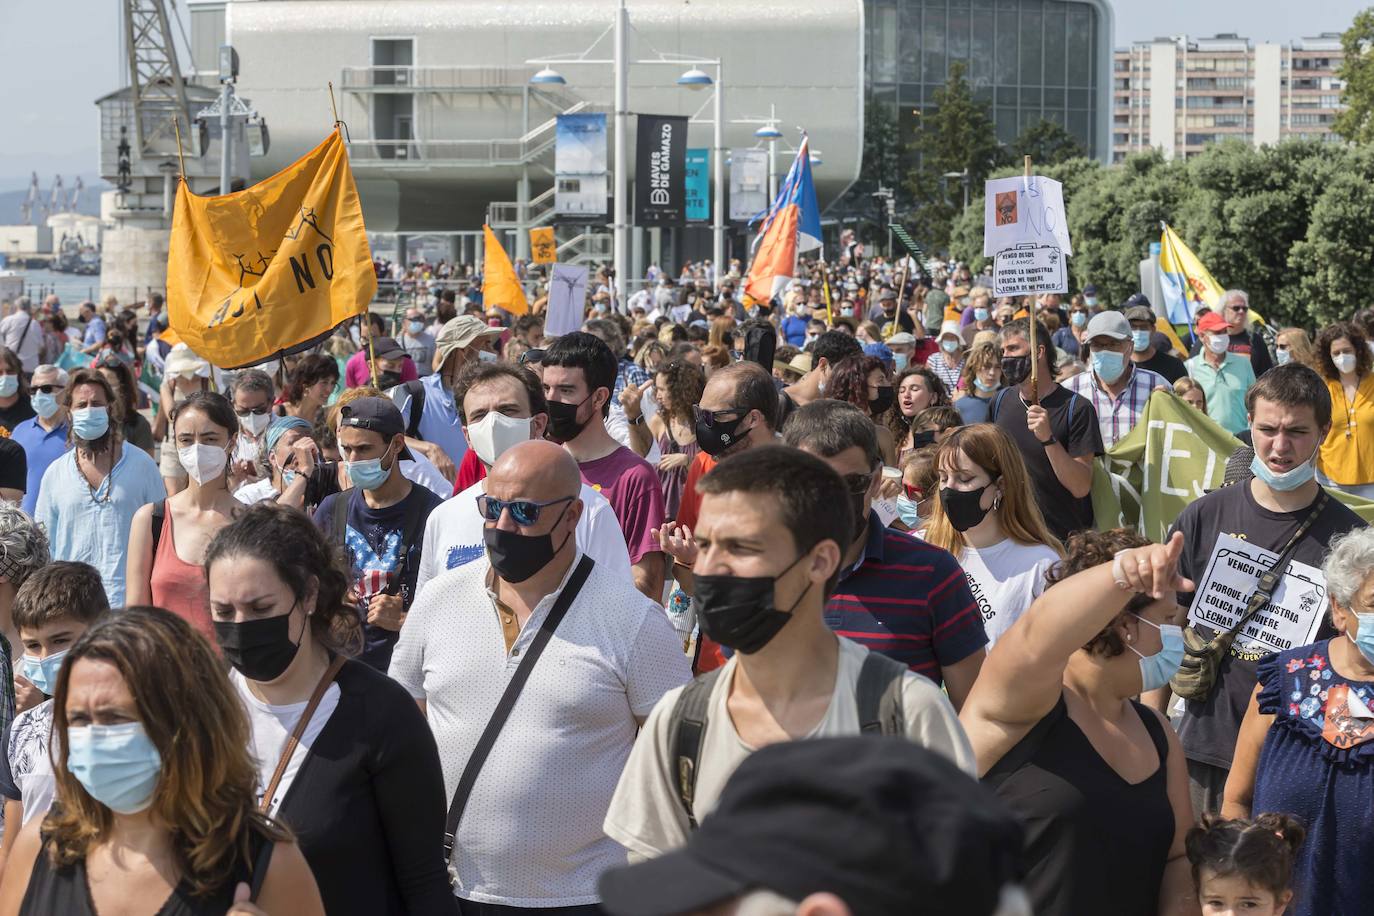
[598,736,1022,916]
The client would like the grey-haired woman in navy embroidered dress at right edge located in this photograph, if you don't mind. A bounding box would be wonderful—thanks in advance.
[1221,527,1374,916]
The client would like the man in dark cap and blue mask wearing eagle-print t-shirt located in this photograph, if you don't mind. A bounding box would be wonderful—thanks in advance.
[315,397,441,672]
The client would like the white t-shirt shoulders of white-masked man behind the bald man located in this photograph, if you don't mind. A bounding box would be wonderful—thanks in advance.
[415,478,633,595]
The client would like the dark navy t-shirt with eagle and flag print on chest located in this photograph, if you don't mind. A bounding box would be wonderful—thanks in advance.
[315,483,441,672]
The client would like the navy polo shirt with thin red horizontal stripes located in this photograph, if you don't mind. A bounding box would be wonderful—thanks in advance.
[826,512,988,684]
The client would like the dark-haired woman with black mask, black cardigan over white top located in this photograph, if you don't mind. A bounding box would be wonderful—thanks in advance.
[205,503,458,916]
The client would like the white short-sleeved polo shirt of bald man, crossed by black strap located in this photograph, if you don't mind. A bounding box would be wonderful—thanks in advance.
[389,553,691,906]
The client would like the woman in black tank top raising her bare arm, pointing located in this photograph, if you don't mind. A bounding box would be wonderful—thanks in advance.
[959,529,1197,916]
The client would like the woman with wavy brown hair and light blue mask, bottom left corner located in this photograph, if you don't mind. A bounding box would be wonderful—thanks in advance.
[0,607,321,916]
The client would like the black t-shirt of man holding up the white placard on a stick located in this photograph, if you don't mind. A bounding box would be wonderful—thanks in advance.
[992,385,1103,541]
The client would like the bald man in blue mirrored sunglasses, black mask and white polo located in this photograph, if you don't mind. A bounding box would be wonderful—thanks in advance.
[390,439,690,915]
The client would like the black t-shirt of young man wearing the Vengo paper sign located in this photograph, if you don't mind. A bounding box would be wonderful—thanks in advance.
[1171,481,1364,769]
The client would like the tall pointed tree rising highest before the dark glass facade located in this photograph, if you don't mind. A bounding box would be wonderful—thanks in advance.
[905,60,1004,249]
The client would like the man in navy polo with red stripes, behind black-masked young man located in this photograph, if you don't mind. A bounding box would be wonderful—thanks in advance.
[783,400,988,710]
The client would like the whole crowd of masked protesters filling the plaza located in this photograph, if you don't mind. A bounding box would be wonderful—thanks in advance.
[0,248,1374,916]
